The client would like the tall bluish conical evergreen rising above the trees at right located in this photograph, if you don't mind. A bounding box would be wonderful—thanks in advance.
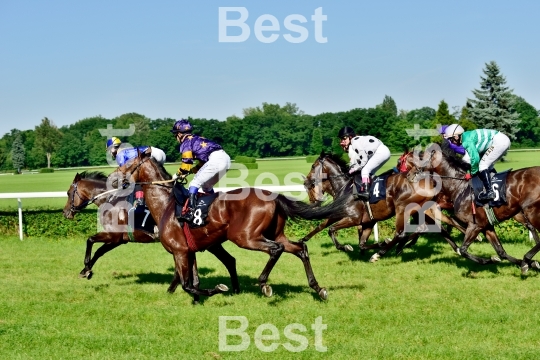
[467,61,519,139]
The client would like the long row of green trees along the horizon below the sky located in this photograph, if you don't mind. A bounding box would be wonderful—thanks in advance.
[0,61,540,171]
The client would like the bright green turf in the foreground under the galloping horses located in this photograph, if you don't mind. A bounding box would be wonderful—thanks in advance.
[0,233,540,360]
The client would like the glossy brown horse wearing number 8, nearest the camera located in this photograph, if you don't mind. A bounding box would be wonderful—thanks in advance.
[118,154,347,299]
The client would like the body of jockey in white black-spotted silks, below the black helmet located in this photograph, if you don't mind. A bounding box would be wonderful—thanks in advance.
[349,135,390,200]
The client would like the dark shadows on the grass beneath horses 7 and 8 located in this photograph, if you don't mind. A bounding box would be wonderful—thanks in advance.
[114,267,364,305]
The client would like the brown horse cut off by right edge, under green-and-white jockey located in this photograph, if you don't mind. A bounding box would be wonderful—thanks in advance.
[407,142,540,273]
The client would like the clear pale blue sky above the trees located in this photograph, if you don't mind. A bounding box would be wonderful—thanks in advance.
[0,0,540,136]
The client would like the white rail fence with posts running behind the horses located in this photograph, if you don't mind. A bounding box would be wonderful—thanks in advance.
[0,185,379,241]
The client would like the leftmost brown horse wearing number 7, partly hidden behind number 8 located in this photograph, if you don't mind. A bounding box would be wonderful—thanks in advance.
[63,172,240,293]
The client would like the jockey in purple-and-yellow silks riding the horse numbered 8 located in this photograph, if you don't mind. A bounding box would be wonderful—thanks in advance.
[171,119,231,222]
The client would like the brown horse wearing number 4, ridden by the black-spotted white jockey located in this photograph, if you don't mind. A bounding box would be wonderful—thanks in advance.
[302,153,465,262]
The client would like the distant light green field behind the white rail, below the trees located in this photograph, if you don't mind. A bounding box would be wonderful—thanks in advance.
[0,152,540,210]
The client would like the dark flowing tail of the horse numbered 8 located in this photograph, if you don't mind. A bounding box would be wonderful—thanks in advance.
[275,194,349,220]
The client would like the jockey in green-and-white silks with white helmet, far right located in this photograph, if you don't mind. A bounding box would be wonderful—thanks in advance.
[445,124,510,200]
